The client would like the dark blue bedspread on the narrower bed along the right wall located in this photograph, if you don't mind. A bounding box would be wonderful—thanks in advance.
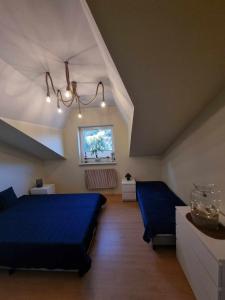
[136,181,185,242]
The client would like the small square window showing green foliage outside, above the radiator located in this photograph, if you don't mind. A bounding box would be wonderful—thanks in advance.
[79,126,115,164]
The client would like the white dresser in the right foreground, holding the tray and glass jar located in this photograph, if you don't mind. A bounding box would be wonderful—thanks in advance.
[176,207,225,300]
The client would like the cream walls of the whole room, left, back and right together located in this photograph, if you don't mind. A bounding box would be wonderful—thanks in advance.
[4,86,225,199]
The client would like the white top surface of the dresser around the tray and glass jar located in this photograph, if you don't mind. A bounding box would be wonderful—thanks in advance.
[176,206,225,261]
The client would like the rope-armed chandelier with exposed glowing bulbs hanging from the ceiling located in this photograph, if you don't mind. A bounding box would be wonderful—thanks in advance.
[45,61,106,119]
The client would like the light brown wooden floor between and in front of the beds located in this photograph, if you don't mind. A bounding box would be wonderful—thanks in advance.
[0,196,194,300]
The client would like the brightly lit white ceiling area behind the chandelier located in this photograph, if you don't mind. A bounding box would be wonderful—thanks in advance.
[0,0,114,127]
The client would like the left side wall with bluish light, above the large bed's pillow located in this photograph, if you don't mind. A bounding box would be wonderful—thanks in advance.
[0,143,44,196]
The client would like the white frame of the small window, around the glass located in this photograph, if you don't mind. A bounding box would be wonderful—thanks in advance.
[78,125,116,165]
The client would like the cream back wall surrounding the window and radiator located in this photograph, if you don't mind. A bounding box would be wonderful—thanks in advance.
[45,107,161,193]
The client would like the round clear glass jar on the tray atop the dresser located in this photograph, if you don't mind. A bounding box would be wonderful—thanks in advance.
[190,184,221,230]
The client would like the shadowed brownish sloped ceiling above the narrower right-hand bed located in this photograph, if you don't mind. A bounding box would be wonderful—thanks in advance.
[87,0,225,156]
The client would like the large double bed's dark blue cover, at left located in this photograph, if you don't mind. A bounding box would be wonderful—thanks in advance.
[0,189,106,275]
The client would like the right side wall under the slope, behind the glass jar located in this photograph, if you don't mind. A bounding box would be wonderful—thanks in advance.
[162,90,225,204]
